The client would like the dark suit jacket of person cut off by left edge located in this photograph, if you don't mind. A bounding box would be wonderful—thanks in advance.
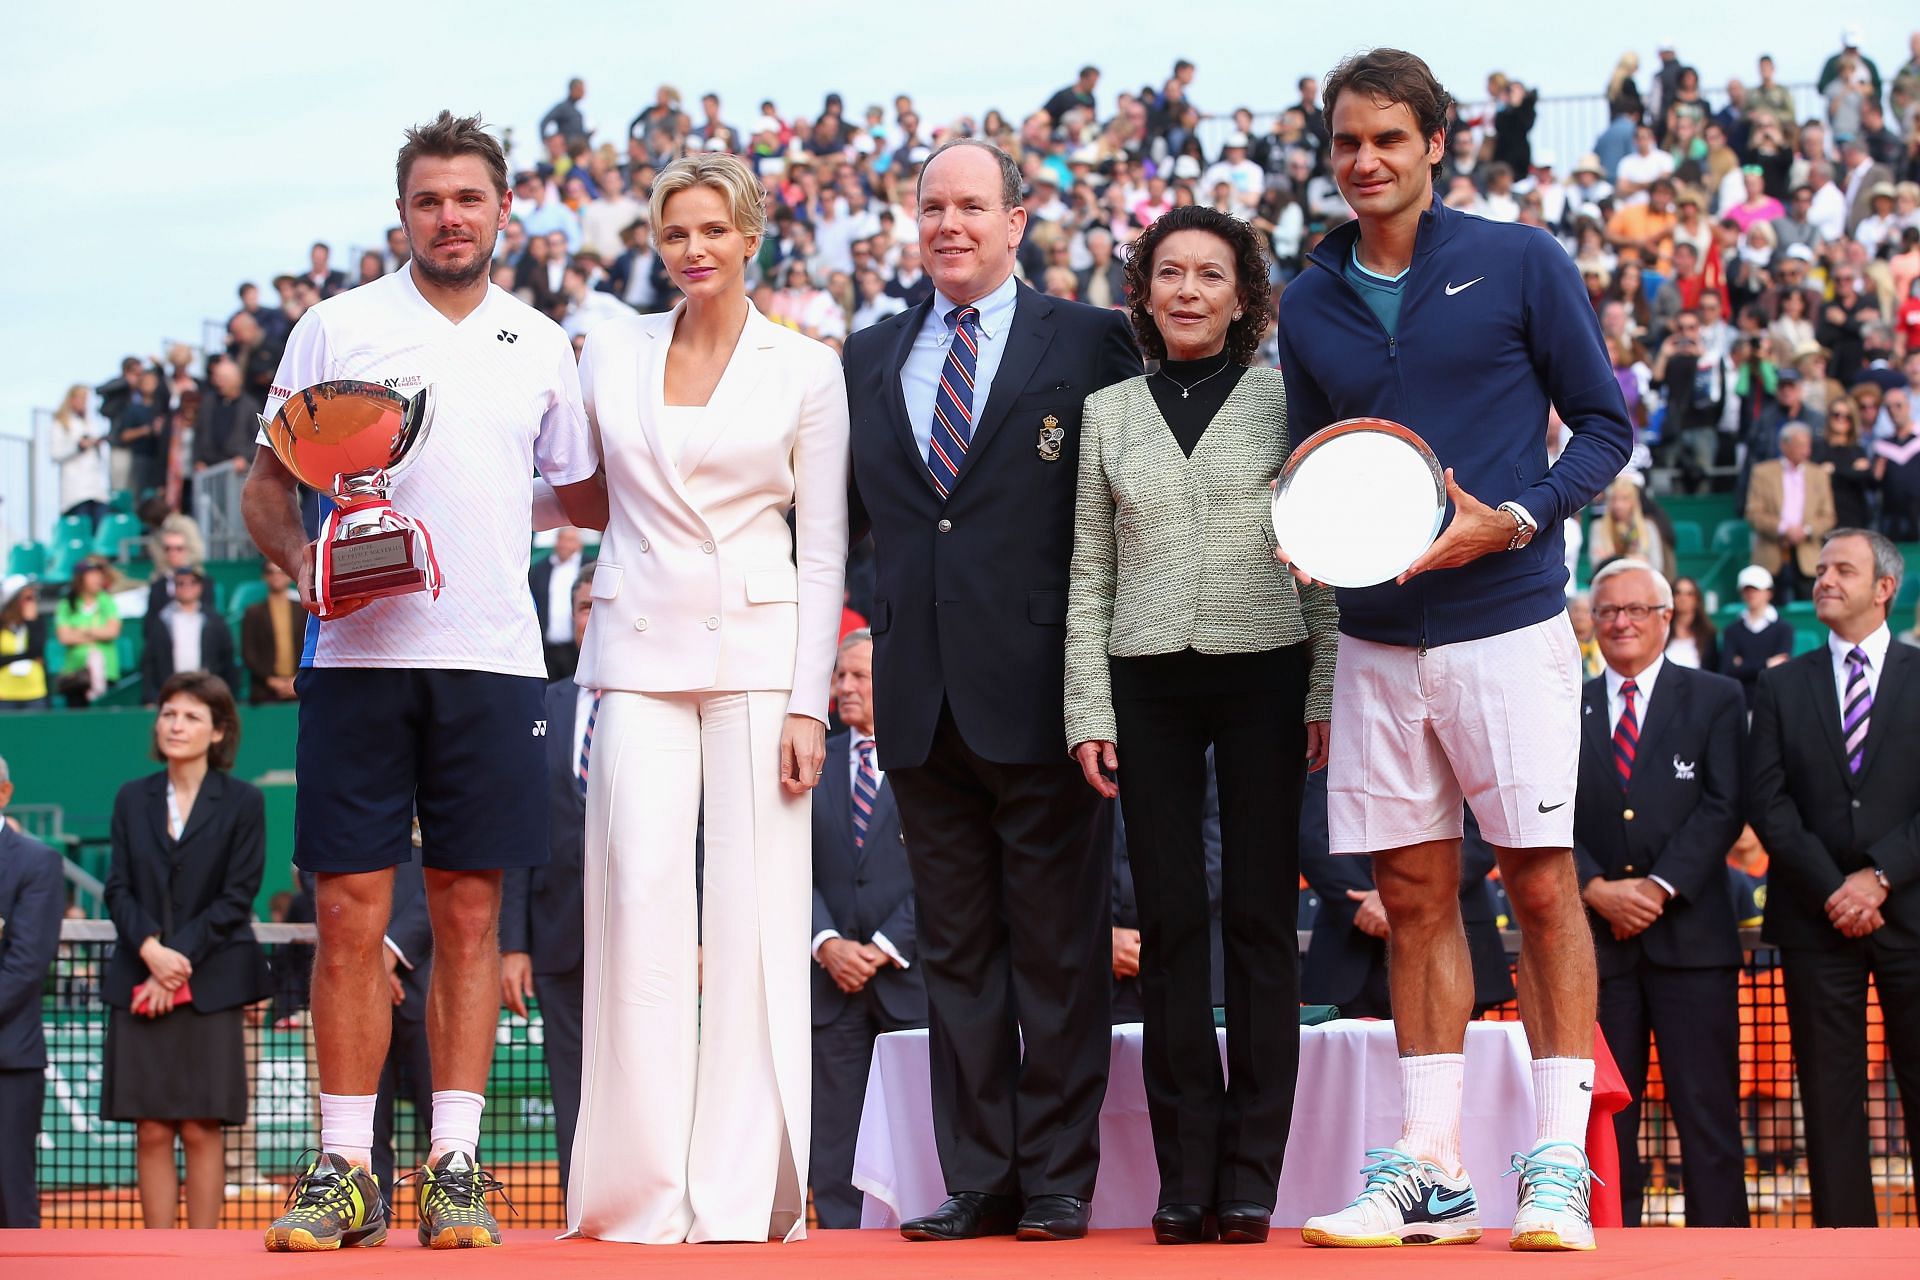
[0,818,67,1071]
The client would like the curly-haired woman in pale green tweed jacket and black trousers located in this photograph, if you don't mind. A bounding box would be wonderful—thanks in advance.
[1066,207,1336,1244]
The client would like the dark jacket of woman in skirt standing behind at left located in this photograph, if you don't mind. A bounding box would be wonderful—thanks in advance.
[100,770,273,1013]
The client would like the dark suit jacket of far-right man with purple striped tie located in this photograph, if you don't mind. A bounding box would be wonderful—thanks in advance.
[1747,641,1920,950]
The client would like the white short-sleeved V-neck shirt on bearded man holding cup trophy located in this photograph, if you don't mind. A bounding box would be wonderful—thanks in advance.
[261,267,599,679]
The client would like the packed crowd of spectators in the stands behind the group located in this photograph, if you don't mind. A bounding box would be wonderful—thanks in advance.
[0,33,1920,1226]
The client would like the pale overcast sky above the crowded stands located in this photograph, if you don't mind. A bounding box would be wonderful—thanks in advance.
[0,0,1920,545]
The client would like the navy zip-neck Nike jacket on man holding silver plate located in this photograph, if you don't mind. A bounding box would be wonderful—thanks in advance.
[1279,198,1632,645]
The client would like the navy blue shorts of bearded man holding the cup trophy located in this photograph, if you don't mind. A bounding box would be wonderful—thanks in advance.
[294,666,547,873]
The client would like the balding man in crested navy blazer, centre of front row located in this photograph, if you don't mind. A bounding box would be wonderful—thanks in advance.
[845,138,1140,1240]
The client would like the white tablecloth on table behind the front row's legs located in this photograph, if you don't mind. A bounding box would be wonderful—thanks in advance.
[852,1019,1534,1228]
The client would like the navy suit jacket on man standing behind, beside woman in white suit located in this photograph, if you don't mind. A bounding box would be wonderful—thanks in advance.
[814,733,927,1027]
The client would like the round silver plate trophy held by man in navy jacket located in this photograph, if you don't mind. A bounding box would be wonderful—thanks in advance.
[1273,418,1446,587]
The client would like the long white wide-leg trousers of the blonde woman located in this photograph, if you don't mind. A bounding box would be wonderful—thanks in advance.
[566,691,812,1244]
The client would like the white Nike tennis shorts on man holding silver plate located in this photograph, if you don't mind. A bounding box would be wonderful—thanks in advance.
[1327,614,1580,854]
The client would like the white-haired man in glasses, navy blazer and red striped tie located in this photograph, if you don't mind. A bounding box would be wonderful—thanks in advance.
[1572,560,1747,1226]
